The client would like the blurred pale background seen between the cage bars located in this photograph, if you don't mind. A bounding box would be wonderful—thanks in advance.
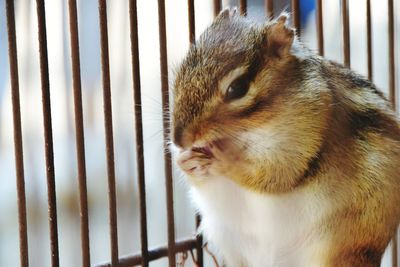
[0,0,400,266]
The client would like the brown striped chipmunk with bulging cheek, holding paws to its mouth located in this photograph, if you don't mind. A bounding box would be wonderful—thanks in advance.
[171,10,400,267]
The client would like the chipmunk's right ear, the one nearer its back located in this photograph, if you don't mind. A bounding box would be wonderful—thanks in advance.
[265,14,295,57]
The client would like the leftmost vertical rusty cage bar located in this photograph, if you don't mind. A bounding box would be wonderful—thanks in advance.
[6,0,29,267]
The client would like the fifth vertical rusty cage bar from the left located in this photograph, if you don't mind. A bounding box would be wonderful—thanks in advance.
[129,0,149,267]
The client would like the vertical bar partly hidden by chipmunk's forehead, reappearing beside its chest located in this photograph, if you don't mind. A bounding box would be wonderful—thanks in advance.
[188,0,203,267]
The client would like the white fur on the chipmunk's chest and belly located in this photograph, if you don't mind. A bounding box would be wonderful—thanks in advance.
[192,178,324,267]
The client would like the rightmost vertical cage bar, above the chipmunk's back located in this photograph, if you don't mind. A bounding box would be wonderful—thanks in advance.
[388,0,397,110]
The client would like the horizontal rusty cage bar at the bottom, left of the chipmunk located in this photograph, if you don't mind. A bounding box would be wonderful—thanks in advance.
[95,238,197,267]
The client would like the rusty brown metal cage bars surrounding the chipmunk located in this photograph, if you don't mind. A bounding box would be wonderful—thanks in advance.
[2,0,398,266]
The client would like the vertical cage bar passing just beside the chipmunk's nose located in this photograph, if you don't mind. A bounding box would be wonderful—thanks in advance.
[158,0,176,267]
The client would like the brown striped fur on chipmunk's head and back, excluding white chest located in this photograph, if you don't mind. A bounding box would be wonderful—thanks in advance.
[172,11,400,266]
